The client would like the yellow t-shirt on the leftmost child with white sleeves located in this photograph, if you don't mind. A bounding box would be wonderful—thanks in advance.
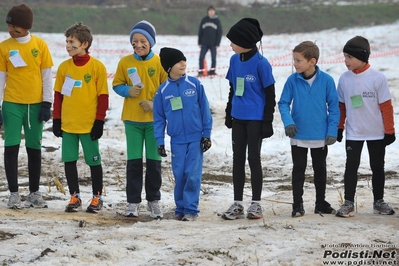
[0,35,53,104]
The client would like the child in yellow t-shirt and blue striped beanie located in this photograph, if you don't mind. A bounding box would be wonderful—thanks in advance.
[112,20,167,219]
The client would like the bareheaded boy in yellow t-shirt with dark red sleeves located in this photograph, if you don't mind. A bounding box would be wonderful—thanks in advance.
[53,22,108,212]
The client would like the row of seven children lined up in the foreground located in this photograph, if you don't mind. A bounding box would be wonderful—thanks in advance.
[0,4,395,221]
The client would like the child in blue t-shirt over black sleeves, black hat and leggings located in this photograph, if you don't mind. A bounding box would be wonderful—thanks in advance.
[222,18,276,220]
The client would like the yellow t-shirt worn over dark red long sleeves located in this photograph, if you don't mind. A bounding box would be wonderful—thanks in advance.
[54,57,108,134]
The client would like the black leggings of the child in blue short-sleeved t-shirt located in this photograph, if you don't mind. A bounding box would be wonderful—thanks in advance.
[232,119,263,201]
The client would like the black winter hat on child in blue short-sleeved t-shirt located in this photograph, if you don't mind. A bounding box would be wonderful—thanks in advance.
[226,18,263,48]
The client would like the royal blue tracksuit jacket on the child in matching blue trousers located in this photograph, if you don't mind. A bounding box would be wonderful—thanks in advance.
[153,75,212,146]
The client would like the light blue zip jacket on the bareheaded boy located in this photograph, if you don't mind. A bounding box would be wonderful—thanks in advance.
[278,66,340,140]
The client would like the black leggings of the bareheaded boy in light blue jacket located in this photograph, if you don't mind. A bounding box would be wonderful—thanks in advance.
[291,146,328,205]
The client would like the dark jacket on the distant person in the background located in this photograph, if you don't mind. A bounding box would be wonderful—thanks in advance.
[198,15,222,46]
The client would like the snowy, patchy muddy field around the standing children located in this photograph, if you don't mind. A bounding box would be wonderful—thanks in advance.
[0,22,399,266]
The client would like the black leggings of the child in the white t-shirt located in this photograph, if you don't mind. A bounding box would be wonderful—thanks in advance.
[344,140,385,201]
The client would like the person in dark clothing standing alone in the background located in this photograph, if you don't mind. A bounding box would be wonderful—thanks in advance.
[198,6,222,77]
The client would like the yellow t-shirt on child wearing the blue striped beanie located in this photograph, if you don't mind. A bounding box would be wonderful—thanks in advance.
[112,54,168,122]
